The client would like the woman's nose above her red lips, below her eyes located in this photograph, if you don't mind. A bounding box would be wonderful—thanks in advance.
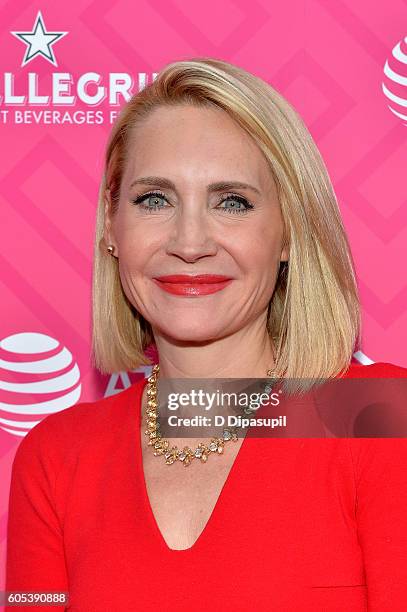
[166,209,217,261]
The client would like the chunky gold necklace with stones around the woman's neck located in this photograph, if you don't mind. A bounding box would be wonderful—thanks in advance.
[144,364,273,467]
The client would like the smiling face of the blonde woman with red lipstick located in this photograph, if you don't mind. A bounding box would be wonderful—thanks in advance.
[105,105,287,342]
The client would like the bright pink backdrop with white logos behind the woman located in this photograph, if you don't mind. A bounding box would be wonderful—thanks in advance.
[0,0,407,590]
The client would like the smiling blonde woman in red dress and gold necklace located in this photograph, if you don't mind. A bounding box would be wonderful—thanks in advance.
[6,58,407,612]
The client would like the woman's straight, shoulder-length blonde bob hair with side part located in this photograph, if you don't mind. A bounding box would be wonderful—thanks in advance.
[92,57,360,379]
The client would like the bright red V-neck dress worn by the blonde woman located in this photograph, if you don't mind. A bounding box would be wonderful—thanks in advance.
[6,364,407,612]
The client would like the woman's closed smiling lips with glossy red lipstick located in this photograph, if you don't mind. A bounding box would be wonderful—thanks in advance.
[153,274,233,296]
